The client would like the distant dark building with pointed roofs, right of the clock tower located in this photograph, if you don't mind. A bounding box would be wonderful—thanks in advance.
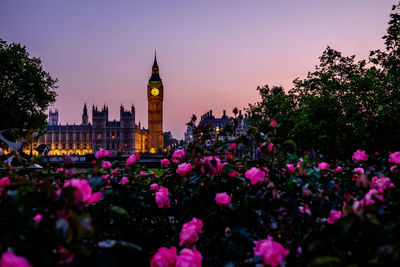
[184,110,249,143]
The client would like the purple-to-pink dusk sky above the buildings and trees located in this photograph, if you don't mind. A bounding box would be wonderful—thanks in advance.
[0,0,397,138]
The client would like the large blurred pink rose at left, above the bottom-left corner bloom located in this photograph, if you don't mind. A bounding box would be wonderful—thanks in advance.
[64,179,103,204]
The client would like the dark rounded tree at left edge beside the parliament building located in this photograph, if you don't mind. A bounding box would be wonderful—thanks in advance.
[0,39,57,134]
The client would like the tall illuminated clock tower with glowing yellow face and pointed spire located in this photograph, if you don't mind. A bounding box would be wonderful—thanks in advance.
[147,55,164,153]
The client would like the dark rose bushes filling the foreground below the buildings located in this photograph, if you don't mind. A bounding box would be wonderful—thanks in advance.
[0,124,400,266]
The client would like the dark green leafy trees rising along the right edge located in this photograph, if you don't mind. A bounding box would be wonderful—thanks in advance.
[247,4,400,159]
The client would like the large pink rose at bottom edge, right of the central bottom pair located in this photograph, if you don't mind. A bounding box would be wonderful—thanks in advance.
[254,236,289,267]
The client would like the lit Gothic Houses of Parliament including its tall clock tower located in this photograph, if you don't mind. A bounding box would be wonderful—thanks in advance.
[24,56,164,155]
